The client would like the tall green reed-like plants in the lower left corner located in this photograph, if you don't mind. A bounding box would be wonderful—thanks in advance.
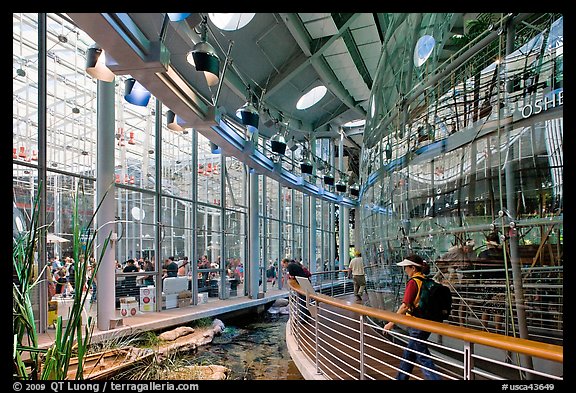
[12,179,112,380]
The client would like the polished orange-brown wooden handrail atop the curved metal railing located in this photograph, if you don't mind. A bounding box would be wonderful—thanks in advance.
[288,279,564,363]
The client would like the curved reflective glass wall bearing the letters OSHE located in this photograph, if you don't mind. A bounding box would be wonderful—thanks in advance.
[358,14,564,343]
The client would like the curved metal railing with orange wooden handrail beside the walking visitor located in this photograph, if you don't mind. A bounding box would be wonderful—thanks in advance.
[288,272,564,381]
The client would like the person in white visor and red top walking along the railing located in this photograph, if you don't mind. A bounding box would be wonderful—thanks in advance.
[384,254,441,380]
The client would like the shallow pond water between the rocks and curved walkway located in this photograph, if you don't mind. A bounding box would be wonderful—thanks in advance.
[193,312,304,380]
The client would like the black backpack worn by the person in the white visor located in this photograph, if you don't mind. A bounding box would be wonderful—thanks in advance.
[410,276,452,322]
